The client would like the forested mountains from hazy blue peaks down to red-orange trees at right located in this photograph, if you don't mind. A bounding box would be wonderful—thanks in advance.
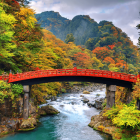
[35,11,139,73]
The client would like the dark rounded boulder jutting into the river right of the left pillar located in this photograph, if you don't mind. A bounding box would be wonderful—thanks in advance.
[38,105,60,116]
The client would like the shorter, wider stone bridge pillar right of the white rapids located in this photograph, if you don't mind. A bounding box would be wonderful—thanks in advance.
[106,85,116,108]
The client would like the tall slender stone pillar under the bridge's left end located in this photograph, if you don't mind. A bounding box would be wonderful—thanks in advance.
[23,85,30,119]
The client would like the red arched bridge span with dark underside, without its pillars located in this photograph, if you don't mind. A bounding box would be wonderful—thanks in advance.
[0,67,139,88]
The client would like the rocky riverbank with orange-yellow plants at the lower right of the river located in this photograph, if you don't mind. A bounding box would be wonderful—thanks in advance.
[88,108,140,140]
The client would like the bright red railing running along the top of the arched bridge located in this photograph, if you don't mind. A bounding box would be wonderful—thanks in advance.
[9,68,137,82]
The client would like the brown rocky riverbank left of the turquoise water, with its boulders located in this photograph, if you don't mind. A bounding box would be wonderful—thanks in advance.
[0,105,60,137]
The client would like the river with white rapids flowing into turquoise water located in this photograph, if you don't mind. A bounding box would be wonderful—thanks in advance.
[0,90,112,140]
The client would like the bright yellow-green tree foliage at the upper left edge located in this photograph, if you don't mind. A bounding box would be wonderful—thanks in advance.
[0,3,16,58]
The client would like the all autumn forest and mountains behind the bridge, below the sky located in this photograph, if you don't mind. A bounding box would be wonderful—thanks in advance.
[0,0,140,102]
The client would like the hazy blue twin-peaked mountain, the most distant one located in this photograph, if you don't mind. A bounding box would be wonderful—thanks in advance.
[35,11,99,45]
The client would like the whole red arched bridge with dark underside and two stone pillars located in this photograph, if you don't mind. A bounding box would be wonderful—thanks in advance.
[8,67,139,119]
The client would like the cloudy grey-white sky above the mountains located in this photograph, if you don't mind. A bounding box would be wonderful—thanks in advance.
[29,0,140,46]
